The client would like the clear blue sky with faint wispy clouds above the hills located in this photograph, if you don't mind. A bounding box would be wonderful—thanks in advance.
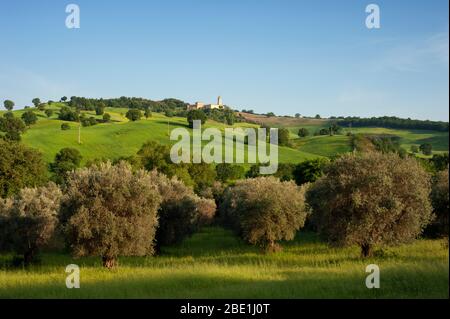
[0,0,449,121]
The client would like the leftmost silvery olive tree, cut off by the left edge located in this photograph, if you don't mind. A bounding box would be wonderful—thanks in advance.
[0,183,62,265]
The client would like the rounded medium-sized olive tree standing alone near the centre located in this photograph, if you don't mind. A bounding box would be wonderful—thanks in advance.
[220,177,307,251]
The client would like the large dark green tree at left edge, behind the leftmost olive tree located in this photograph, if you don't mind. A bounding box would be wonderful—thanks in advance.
[0,139,47,197]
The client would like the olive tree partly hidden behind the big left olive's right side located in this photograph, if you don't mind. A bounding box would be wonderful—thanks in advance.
[151,171,216,250]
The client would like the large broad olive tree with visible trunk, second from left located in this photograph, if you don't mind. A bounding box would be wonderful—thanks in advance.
[60,162,161,268]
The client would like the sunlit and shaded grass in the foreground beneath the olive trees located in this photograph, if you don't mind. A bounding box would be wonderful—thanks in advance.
[0,227,449,298]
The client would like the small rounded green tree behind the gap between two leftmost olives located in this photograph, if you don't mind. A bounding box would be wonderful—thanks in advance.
[50,147,83,184]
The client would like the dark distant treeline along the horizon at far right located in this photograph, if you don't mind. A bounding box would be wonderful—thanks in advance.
[338,116,449,132]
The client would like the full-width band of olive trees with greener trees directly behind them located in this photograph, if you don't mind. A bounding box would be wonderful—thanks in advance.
[0,132,449,267]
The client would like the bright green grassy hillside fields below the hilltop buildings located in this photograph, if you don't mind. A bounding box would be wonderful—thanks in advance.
[2,103,449,163]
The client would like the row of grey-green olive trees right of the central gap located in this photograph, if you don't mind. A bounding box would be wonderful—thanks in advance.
[219,152,449,257]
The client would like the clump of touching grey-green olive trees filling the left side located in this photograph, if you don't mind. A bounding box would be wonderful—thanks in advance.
[0,162,216,267]
